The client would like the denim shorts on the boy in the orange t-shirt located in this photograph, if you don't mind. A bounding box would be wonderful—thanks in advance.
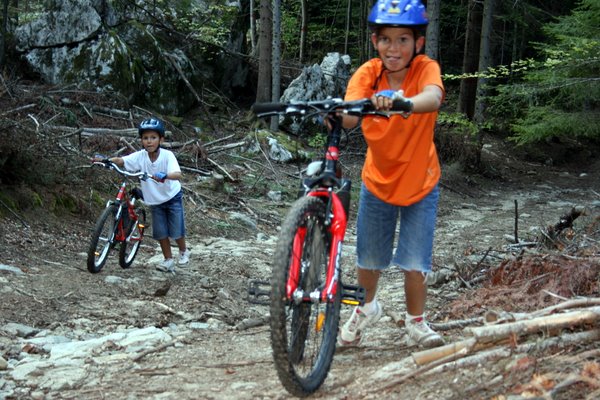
[356,183,439,274]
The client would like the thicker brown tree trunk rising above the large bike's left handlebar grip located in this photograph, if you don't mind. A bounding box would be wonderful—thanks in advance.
[256,0,273,103]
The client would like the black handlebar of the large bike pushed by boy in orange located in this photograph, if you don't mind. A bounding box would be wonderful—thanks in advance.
[252,98,412,117]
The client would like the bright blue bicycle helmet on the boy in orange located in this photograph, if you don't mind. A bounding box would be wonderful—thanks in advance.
[367,0,429,28]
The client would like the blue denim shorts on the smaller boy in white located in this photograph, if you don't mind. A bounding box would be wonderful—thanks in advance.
[150,191,185,240]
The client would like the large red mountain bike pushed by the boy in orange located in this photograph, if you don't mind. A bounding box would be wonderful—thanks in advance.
[249,99,410,396]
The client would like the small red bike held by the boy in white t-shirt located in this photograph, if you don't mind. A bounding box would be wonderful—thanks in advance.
[87,160,149,273]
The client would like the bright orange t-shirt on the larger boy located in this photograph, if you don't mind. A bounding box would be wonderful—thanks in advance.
[345,55,444,206]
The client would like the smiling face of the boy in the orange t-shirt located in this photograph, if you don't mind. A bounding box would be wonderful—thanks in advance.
[371,27,425,71]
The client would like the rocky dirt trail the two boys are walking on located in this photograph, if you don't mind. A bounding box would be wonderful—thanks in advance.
[0,141,600,399]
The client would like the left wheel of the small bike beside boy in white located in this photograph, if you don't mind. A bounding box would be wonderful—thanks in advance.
[87,204,118,274]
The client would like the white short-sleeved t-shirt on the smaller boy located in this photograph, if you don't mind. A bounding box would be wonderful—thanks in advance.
[123,148,181,205]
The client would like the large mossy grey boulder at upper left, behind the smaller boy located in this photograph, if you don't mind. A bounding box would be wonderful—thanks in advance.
[15,0,239,114]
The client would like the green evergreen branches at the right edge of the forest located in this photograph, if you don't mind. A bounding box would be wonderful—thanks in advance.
[490,0,600,144]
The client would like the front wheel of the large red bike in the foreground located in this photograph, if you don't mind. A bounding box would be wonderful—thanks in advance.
[270,197,341,397]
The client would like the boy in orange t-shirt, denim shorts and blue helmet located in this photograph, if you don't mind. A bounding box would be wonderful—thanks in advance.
[338,0,444,347]
